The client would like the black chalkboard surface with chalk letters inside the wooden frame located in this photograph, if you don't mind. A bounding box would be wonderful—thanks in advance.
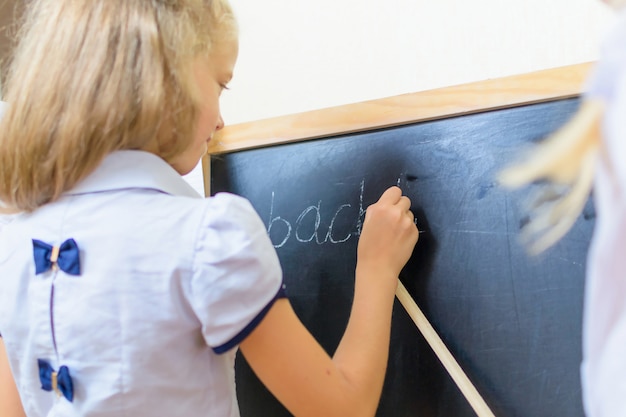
[211,99,595,417]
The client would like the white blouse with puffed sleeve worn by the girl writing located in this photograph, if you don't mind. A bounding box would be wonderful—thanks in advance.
[0,151,282,417]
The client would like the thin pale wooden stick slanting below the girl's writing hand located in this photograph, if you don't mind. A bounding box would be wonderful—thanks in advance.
[396,280,495,417]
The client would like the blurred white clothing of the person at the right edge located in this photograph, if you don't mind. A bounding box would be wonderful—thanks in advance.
[582,8,626,417]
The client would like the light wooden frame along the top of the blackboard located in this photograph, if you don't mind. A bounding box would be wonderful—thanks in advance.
[202,63,592,187]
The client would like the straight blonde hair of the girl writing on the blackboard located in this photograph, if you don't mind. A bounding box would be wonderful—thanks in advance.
[0,0,237,211]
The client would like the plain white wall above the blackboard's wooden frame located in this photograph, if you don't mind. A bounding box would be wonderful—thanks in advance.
[189,0,613,192]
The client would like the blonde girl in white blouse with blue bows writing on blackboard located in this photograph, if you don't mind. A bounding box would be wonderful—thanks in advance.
[0,0,418,417]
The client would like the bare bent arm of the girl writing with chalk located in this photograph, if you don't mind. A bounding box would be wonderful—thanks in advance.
[240,187,418,417]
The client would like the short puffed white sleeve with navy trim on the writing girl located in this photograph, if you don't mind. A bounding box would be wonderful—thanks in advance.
[191,193,285,353]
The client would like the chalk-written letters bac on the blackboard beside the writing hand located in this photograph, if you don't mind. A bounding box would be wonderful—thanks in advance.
[267,180,376,248]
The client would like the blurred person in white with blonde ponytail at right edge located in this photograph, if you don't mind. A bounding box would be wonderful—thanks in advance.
[502,0,626,417]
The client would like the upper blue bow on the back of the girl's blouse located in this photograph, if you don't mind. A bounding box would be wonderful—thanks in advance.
[33,239,80,275]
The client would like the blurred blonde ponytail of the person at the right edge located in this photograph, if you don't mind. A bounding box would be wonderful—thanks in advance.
[500,99,604,253]
